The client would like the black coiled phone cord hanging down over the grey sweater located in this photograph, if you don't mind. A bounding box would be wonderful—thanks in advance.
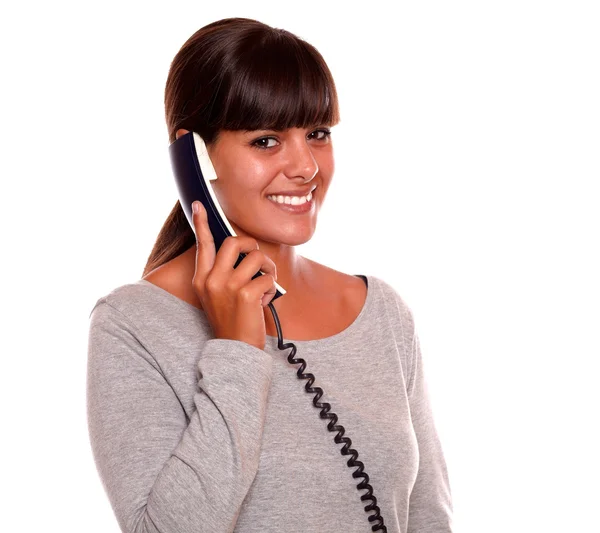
[268,296,387,533]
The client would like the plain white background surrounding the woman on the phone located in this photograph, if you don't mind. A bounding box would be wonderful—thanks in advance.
[0,0,600,533]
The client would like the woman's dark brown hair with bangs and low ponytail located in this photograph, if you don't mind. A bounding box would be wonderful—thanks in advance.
[142,18,340,277]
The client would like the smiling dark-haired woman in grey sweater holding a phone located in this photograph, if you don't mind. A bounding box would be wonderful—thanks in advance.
[88,18,452,533]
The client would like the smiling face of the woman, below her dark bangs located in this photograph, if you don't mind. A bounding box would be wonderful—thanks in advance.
[177,126,334,246]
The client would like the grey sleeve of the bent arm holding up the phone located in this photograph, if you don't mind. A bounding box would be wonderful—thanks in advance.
[87,302,272,533]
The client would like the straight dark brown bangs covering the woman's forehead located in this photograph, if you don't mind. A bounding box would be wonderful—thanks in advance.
[210,30,340,130]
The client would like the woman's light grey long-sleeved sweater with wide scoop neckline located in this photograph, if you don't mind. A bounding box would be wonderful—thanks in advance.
[87,276,452,533]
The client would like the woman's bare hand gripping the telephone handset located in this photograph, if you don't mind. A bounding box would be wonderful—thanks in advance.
[192,202,277,350]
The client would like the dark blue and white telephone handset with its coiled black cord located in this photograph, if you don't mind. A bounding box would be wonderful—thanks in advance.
[169,131,387,533]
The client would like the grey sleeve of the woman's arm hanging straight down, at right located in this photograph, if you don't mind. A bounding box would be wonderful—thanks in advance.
[407,330,453,533]
